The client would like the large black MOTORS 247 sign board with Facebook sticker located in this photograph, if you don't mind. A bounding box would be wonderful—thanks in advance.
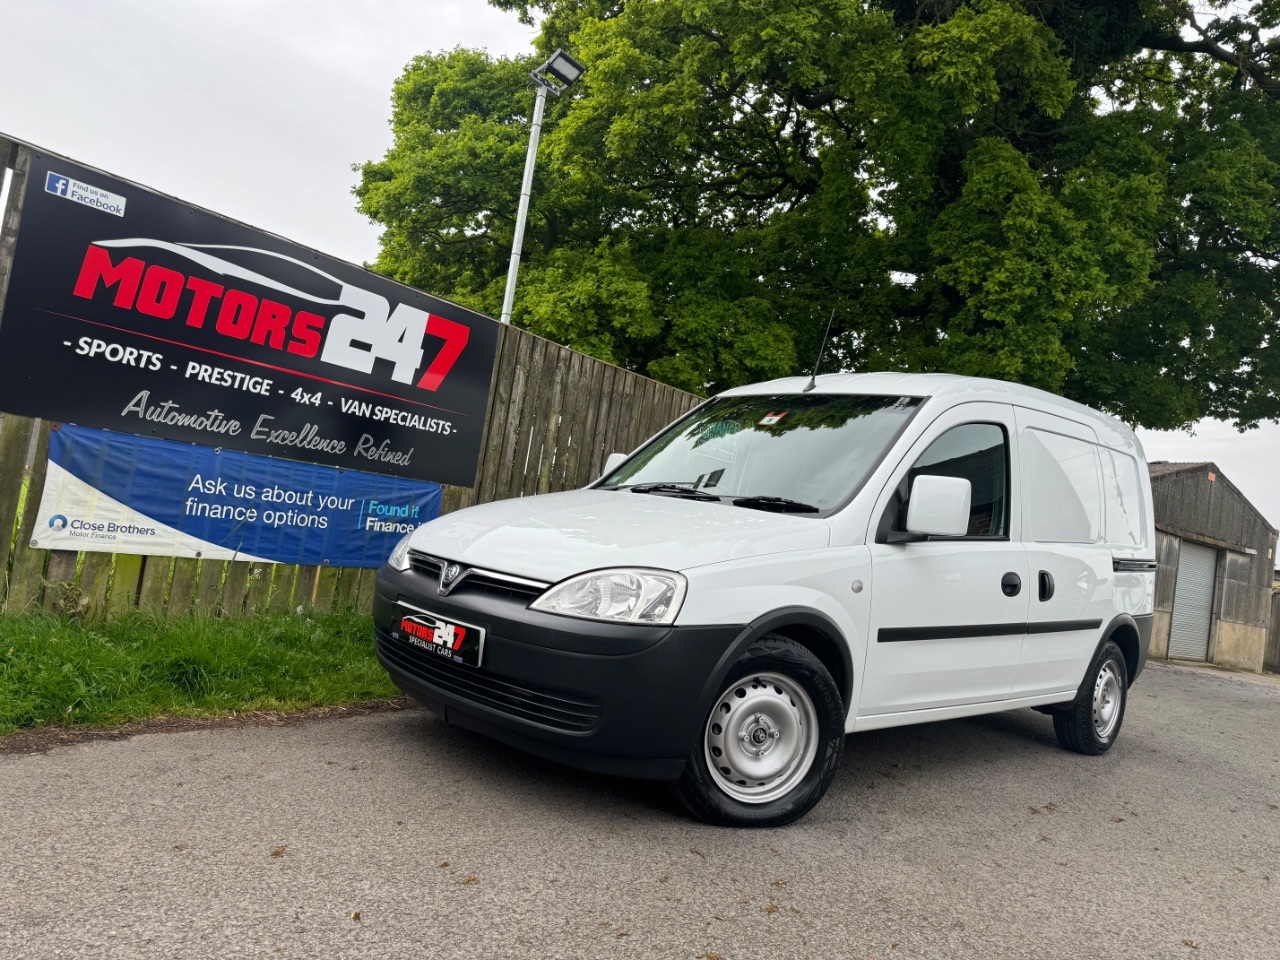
[0,152,498,486]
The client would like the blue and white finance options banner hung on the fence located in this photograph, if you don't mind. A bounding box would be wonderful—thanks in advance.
[32,425,442,567]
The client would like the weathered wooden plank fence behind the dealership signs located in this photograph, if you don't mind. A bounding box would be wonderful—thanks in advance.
[0,138,699,617]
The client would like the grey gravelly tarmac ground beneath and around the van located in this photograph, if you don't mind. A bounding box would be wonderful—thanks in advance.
[0,664,1280,960]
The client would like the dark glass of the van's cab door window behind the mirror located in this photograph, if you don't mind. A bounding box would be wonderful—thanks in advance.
[904,424,1009,539]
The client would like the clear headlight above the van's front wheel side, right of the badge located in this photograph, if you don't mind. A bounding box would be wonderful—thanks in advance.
[529,568,687,623]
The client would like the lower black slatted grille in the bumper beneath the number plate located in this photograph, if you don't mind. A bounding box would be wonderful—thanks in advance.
[376,628,602,732]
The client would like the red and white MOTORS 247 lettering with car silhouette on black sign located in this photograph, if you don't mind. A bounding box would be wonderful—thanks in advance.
[67,238,471,390]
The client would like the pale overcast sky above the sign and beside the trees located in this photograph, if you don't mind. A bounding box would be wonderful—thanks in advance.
[0,0,1280,526]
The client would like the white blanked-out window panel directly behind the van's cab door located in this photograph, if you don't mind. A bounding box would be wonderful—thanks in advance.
[1021,429,1102,543]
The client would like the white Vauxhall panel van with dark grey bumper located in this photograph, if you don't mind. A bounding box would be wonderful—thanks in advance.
[374,374,1156,826]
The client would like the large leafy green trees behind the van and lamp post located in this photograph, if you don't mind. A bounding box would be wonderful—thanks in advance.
[356,0,1280,428]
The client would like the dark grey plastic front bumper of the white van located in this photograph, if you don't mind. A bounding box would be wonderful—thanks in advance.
[374,566,750,780]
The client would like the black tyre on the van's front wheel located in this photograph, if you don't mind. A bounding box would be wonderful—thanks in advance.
[676,634,845,827]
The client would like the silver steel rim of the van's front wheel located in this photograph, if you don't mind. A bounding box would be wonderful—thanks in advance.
[703,673,818,804]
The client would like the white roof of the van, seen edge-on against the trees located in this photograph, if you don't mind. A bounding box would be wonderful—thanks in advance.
[721,372,1142,456]
